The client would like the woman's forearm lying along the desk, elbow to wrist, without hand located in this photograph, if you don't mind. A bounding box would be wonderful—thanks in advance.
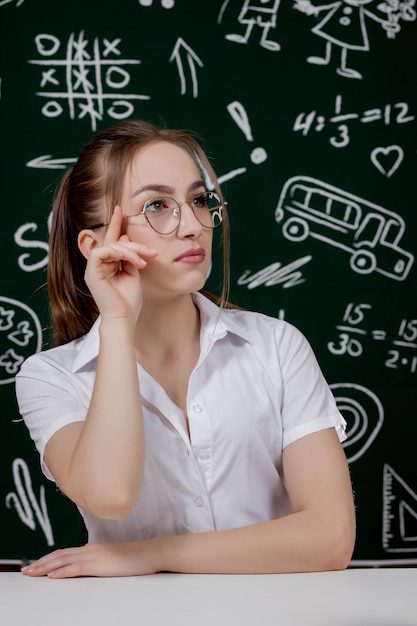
[156,511,355,574]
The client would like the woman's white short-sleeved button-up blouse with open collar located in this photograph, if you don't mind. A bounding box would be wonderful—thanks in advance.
[16,294,346,541]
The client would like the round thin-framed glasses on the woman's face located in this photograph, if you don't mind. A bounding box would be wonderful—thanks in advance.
[90,191,227,235]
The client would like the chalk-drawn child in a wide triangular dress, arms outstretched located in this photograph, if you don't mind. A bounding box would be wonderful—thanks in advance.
[294,0,400,79]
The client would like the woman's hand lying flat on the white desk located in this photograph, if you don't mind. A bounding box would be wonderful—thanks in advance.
[22,539,158,578]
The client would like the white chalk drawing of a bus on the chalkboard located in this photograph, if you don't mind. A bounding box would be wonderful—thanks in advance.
[275,176,414,280]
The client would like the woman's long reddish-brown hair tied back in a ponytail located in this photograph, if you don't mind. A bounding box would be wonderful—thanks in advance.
[48,120,229,345]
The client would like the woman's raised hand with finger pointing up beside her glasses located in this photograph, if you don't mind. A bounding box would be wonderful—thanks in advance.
[85,206,157,324]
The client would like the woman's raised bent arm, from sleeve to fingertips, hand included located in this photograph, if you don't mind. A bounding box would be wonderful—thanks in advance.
[45,207,155,519]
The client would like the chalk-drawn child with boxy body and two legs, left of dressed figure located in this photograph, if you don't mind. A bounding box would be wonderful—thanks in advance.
[226,0,281,52]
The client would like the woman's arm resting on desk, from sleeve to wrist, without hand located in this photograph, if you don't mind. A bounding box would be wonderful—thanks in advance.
[160,429,355,574]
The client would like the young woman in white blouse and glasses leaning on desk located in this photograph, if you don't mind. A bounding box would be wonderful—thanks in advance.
[16,121,355,578]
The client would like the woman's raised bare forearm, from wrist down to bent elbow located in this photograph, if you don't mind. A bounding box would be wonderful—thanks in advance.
[47,319,145,519]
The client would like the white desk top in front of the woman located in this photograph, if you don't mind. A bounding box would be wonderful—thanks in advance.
[0,568,417,626]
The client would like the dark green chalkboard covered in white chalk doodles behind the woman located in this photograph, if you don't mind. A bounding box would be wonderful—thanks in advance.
[0,0,417,563]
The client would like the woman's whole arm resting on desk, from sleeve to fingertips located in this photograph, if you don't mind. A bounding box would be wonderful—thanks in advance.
[23,428,355,578]
